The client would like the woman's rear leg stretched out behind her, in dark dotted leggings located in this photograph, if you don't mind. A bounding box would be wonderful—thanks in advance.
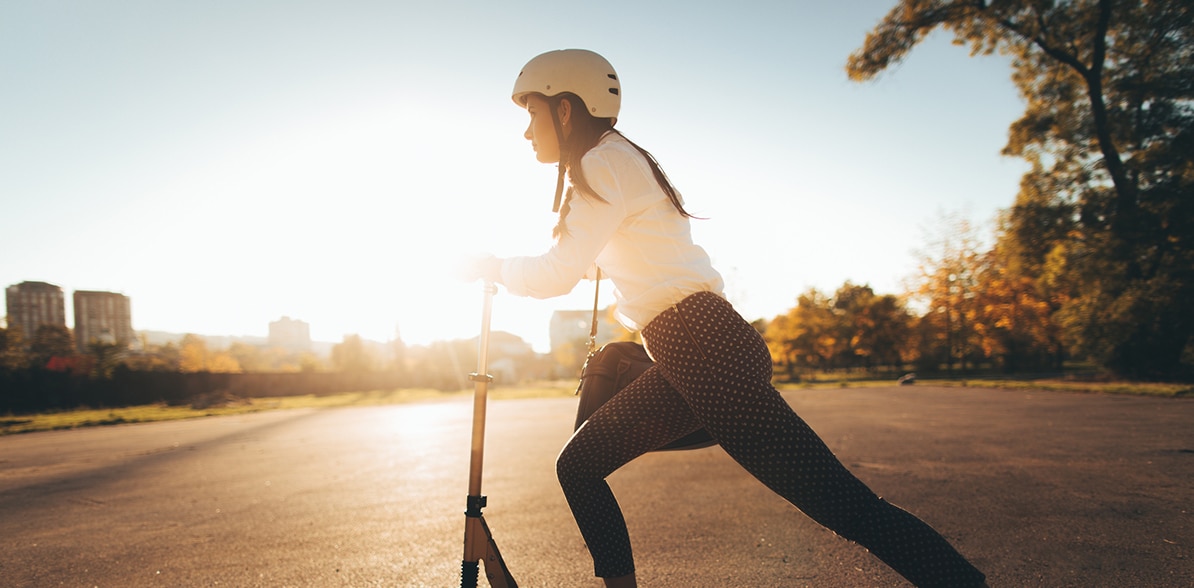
[642,294,983,587]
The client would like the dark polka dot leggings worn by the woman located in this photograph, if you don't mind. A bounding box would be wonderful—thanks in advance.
[556,293,984,588]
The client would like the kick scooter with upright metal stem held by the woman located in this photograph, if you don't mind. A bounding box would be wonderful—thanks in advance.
[460,282,518,588]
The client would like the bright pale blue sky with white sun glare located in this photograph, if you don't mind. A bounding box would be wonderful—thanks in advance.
[0,0,1026,351]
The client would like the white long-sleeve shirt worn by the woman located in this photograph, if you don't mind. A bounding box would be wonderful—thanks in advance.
[501,133,724,330]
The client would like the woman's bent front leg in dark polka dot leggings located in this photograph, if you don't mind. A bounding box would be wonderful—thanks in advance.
[555,367,698,578]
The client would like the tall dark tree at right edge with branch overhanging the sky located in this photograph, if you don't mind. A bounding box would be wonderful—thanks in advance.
[847,0,1194,376]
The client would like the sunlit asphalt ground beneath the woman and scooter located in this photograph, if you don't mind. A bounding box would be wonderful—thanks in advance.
[0,385,1194,588]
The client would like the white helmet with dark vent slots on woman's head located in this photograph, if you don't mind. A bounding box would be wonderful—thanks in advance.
[512,49,622,118]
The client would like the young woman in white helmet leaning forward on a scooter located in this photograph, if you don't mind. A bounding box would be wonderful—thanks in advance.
[472,49,985,588]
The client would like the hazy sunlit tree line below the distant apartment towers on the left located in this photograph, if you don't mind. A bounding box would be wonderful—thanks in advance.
[0,325,550,414]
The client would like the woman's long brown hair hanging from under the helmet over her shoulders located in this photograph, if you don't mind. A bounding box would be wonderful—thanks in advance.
[548,92,695,239]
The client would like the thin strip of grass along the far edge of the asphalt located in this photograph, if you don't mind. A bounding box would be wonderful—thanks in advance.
[7,379,1194,435]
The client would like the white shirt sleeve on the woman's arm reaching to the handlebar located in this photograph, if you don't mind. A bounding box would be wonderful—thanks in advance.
[501,153,627,299]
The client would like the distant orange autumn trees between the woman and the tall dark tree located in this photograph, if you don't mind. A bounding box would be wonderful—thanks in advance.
[761,215,1081,379]
